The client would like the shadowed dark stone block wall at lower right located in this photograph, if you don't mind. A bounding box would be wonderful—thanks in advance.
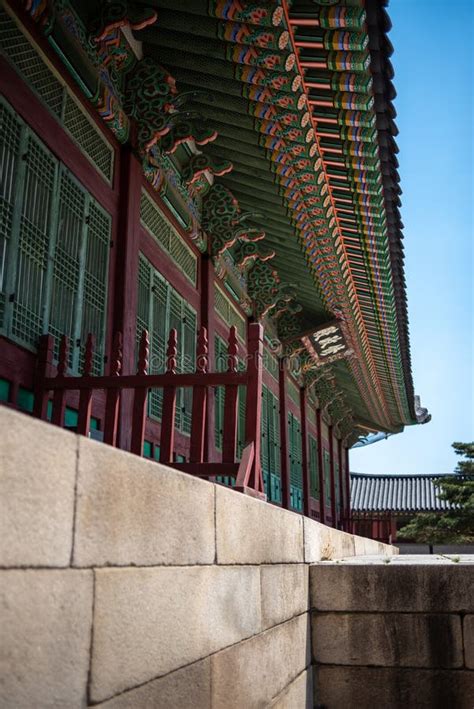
[310,556,474,709]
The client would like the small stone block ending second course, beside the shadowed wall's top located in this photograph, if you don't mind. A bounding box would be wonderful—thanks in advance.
[260,564,308,628]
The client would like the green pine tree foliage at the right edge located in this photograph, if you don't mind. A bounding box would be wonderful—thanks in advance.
[398,443,474,544]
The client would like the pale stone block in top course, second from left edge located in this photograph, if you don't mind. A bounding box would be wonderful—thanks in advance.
[73,438,215,566]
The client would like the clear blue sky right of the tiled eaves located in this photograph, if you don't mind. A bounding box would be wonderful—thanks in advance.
[351,0,474,473]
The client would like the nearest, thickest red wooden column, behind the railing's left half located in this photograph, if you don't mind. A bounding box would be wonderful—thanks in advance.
[113,147,142,450]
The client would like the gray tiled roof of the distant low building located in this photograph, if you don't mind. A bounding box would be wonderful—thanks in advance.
[351,473,452,512]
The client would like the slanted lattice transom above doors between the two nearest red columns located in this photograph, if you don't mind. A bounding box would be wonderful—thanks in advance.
[140,190,197,286]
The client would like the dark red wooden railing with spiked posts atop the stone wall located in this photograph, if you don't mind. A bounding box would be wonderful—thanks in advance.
[33,323,265,499]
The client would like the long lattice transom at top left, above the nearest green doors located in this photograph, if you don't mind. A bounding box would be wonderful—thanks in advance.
[0,11,114,183]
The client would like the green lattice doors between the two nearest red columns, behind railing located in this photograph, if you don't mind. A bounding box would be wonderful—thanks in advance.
[136,254,197,434]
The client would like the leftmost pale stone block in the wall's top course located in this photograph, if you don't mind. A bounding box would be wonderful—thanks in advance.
[0,406,77,566]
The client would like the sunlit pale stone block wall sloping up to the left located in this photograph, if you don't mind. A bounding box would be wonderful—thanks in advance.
[0,407,396,709]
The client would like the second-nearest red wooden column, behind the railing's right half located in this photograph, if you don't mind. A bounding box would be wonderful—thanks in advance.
[200,254,217,463]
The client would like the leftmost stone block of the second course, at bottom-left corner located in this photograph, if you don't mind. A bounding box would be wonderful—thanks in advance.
[0,569,93,709]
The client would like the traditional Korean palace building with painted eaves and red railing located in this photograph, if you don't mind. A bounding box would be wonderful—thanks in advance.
[0,0,427,527]
